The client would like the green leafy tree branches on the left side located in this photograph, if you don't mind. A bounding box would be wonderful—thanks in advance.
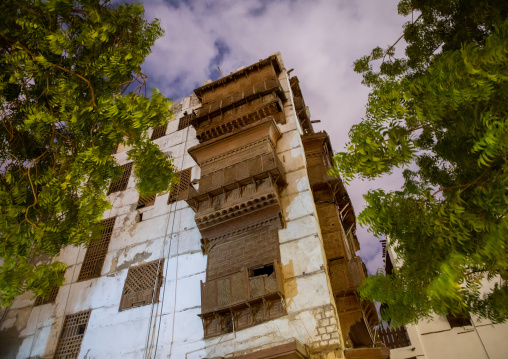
[0,0,174,306]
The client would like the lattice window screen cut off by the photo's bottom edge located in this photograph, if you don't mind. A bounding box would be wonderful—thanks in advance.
[54,310,92,359]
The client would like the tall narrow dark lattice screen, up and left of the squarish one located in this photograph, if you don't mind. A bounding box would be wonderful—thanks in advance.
[78,217,116,281]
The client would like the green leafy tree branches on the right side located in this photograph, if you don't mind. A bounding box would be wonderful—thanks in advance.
[335,0,508,326]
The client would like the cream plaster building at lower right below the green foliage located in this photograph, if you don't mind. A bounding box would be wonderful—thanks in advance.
[387,247,508,359]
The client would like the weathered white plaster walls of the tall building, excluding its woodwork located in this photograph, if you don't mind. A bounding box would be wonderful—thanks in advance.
[0,54,342,359]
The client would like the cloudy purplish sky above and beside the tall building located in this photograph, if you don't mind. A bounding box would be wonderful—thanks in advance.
[142,0,408,273]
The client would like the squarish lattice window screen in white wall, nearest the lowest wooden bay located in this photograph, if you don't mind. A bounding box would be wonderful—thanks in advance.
[119,259,164,310]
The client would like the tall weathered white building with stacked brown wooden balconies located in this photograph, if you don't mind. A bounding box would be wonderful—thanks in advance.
[0,54,389,359]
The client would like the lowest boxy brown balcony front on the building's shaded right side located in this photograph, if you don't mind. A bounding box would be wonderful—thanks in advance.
[329,257,365,295]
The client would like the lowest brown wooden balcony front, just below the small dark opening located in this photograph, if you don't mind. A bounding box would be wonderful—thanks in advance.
[201,261,284,314]
